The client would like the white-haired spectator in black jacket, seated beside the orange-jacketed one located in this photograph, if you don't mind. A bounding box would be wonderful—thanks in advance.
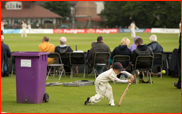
[55,37,73,74]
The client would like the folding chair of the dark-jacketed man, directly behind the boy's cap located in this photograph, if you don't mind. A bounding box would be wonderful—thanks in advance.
[89,52,111,78]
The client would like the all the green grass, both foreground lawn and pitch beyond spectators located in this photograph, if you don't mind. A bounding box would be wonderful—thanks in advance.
[1,33,181,113]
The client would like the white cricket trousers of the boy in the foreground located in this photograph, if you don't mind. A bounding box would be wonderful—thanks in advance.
[90,80,114,104]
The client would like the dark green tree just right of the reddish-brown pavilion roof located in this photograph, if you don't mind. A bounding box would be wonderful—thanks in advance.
[44,1,71,18]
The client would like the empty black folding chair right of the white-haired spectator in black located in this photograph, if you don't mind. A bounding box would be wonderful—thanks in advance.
[70,52,86,78]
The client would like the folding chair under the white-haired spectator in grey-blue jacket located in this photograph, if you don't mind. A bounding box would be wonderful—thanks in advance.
[153,53,163,78]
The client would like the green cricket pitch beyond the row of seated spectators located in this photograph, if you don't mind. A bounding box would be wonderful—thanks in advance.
[4,33,179,52]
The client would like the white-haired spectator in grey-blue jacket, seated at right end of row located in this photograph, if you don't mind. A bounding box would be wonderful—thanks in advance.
[147,35,163,77]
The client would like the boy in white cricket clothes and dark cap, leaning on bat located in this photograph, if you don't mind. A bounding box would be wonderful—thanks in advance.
[85,62,134,106]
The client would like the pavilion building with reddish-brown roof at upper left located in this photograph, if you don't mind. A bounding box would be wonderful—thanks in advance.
[1,1,62,26]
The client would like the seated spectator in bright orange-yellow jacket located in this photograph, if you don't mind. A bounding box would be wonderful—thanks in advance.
[39,36,55,64]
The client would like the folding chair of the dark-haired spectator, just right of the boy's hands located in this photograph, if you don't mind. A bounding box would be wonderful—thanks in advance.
[132,56,154,84]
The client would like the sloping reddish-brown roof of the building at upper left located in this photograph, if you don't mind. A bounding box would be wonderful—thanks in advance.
[1,5,62,18]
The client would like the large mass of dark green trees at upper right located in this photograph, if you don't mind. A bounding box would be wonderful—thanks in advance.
[101,1,181,28]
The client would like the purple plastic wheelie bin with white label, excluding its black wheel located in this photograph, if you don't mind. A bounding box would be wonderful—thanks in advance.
[12,52,49,104]
